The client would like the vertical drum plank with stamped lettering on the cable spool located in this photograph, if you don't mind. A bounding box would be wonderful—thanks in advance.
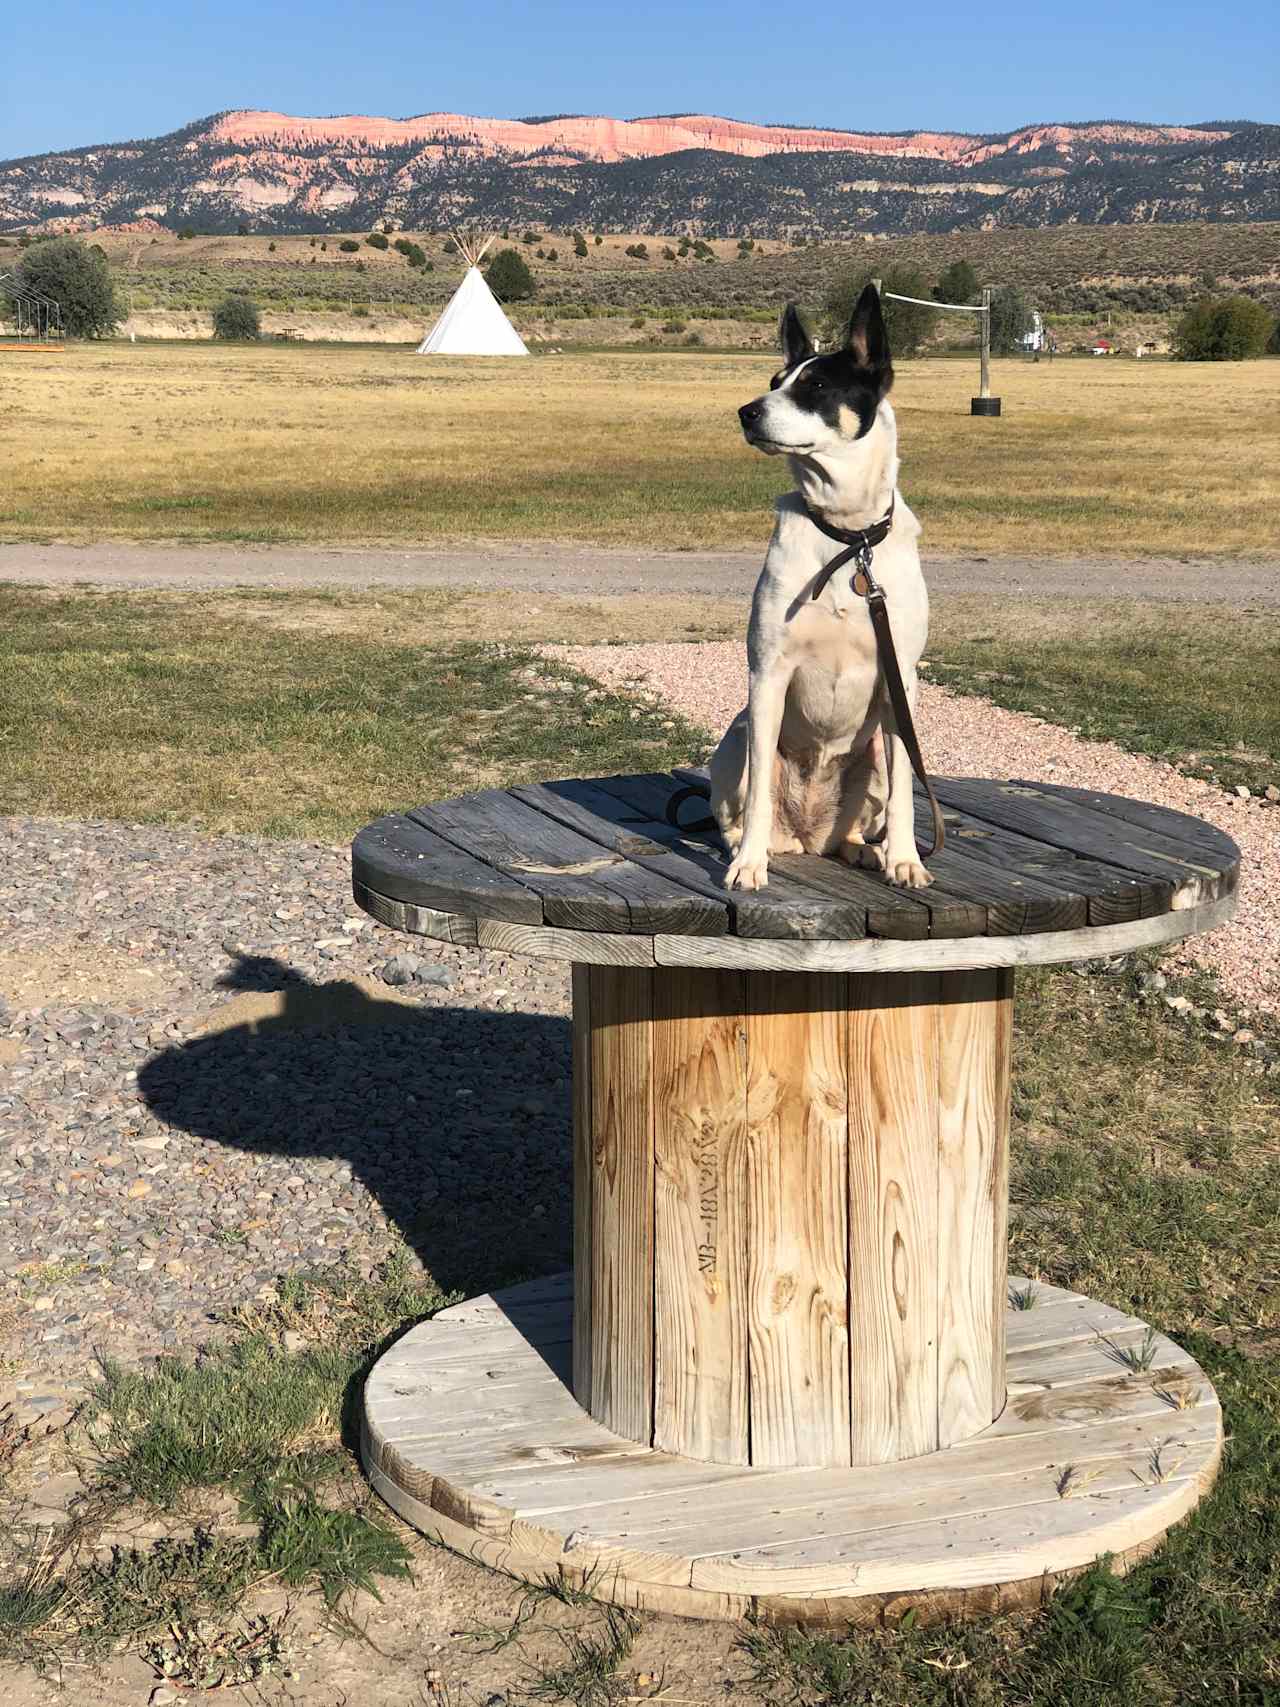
[654,971,749,1465]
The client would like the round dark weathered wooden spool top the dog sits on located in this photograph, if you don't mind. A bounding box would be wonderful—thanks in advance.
[352,773,1241,971]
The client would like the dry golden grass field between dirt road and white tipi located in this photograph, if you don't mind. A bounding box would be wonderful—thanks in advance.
[0,343,1280,556]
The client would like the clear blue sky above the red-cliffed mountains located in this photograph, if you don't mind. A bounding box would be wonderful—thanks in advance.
[0,0,1280,159]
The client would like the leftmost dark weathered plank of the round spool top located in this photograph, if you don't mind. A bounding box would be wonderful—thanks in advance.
[352,813,543,925]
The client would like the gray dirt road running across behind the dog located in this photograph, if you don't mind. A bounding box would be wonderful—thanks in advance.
[0,541,1280,609]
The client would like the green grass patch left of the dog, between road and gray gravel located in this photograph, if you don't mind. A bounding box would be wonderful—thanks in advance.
[0,587,705,840]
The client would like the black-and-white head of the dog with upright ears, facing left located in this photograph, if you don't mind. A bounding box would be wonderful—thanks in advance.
[737,285,893,456]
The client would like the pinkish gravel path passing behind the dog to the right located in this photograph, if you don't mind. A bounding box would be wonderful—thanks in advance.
[546,642,1280,1014]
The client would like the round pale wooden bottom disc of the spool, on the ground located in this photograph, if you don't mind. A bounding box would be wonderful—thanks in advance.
[362,1273,1222,1623]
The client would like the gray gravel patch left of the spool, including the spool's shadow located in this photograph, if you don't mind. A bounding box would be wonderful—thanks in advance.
[0,818,570,1415]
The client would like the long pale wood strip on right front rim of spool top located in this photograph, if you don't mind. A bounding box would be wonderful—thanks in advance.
[654,894,1236,973]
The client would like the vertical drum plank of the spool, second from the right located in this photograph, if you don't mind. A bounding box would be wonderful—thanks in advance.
[848,973,939,1465]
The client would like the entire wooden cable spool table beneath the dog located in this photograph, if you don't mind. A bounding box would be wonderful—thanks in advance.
[353,773,1239,1620]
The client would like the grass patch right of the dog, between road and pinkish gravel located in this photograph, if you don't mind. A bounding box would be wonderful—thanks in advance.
[927,597,1280,790]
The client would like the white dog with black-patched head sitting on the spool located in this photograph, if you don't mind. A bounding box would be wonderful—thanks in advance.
[710,285,934,889]
